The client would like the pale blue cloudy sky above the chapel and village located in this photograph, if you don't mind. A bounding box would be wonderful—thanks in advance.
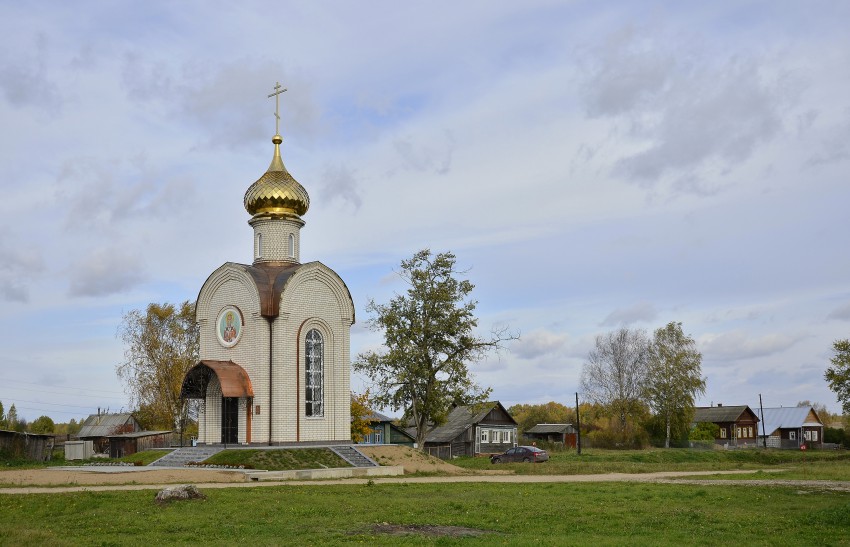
[0,0,850,421]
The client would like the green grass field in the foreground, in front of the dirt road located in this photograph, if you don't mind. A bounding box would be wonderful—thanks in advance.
[0,483,850,545]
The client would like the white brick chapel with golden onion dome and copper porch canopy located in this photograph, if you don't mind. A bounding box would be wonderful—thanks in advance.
[182,85,354,445]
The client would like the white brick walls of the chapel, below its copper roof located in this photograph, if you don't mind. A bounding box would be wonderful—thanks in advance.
[198,262,354,443]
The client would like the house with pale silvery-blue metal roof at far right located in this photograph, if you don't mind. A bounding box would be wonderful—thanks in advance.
[757,406,823,449]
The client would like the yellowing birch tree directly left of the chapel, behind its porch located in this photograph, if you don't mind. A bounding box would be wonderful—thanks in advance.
[116,301,200,432]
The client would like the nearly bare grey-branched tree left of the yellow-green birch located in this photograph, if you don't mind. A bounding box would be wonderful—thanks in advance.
[581,327,649,437]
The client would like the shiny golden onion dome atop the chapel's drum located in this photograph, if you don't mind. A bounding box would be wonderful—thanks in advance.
[245,135,310,217]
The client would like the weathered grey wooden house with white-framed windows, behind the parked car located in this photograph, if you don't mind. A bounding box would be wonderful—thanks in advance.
[407,401,517,460]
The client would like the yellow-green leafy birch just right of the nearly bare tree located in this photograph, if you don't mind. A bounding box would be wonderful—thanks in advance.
[643,322,705,448]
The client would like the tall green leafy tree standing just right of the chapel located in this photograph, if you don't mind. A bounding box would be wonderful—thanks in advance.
[354,249,518,449]
